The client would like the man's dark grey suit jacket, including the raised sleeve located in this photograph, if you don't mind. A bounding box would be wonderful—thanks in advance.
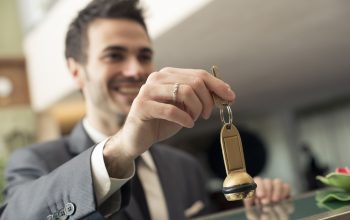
[0,123,208,220]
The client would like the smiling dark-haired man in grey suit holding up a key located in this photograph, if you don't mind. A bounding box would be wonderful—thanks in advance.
[0,0,289,220]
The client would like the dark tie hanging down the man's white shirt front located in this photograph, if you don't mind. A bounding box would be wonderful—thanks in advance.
[131,158,151,220]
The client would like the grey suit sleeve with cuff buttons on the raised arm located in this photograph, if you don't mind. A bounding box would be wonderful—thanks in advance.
[0,148,128,220]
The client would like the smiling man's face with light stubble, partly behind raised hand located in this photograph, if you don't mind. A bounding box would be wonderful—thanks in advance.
[82,19,153,117]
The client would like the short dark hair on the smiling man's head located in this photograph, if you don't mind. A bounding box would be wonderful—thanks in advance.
[65,0,147,63]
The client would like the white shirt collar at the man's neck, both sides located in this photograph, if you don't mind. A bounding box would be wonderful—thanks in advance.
[83,118,157,171]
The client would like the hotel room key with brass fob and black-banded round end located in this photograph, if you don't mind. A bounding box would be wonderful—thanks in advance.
[212,66,256,201]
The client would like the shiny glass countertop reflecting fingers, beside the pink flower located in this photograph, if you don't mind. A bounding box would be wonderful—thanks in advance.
[196,191,350,220]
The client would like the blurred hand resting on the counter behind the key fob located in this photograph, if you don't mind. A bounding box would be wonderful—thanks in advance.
[244,177,290,207]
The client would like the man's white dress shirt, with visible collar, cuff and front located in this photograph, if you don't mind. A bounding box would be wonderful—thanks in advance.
[83,119,169,220]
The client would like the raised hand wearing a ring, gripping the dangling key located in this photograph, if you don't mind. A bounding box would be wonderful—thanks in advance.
[104,68,235,177]
